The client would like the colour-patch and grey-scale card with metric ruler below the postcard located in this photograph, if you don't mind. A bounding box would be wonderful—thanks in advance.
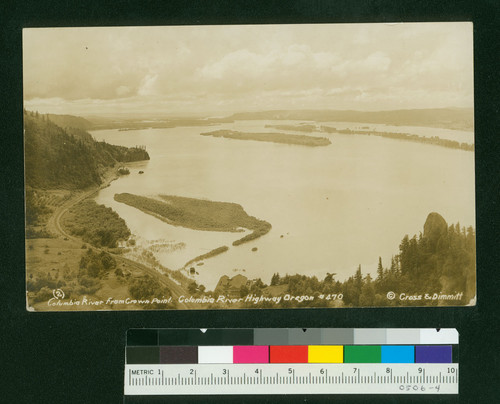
[124,329,459,396]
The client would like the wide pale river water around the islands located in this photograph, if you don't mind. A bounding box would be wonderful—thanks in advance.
[92,121,475,290]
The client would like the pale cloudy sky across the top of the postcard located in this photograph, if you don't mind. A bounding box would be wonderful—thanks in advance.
[23,22,473,116]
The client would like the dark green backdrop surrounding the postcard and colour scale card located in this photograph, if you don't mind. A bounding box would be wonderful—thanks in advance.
[0,0,500,404]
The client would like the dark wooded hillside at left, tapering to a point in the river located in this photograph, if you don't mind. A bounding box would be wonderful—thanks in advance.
[24,111,149,189]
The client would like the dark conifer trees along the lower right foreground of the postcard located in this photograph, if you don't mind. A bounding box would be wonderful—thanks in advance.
[237,213,476,308]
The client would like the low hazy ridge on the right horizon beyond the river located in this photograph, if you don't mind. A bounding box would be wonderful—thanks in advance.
[228,108,474,130]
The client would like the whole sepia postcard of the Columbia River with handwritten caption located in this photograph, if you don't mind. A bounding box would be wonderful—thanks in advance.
[23,22,476,312]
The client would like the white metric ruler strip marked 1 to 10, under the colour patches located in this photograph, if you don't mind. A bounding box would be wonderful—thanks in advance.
[125,363,458,395]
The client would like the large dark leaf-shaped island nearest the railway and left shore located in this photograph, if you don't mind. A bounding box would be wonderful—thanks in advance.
[114,193,271,246]
